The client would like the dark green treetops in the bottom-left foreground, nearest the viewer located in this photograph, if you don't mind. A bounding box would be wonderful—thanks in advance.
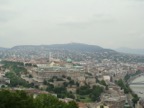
[0,90,78,108]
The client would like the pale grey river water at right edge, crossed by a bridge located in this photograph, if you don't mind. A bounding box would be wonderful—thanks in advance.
[130,76,144,98]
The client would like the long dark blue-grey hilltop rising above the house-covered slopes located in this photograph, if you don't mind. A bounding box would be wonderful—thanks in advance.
[11,43,115,52]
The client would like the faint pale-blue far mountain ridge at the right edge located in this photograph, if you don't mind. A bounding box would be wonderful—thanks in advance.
[116,48,144,55]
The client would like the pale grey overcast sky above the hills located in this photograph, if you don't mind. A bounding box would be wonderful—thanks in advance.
[0,0,144,49]
